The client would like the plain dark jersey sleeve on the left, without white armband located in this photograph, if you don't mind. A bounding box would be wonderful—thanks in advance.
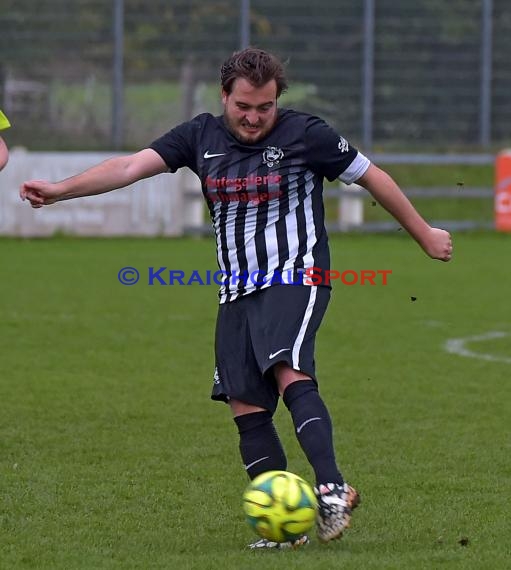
[149,119,200,172]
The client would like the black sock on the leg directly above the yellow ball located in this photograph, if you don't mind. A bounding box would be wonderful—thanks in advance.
[234,411,287,479]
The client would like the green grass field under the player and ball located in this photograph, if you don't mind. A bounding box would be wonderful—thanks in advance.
[0,233,511,570]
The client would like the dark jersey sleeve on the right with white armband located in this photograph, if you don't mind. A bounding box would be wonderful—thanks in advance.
[305,116,370,184]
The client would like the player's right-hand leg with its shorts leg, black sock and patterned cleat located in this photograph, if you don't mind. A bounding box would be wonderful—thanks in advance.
[256,286,359,542]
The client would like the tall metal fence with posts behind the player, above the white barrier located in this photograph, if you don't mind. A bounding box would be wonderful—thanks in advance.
[0,0,511,152]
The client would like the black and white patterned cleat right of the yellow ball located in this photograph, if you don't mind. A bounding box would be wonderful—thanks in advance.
[314,483,360,542]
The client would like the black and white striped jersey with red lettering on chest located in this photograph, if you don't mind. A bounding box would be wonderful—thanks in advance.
[149,109,369,303]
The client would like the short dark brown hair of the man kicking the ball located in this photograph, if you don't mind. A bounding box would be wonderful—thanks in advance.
[220,47,287,97]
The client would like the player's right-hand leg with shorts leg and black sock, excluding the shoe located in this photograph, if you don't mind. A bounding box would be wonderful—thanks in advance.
[249,285,344,485]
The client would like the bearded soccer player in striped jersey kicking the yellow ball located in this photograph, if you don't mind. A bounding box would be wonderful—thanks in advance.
[20,48,452,548]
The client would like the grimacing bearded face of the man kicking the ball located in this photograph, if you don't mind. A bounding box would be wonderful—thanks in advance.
[222,77,277,144]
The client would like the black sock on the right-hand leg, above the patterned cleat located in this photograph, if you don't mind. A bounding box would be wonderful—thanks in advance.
[282,380,344,485]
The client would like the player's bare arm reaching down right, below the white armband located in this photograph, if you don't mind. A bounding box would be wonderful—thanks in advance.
[357,164,452,261]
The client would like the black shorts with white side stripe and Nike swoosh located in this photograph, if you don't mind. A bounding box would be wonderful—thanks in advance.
[211,285,330,413]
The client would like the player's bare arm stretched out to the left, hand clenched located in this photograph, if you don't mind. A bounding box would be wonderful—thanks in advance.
[20,149,168,208]
